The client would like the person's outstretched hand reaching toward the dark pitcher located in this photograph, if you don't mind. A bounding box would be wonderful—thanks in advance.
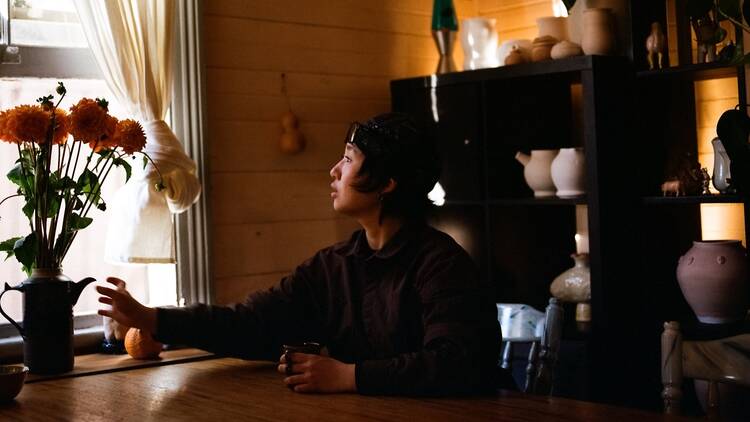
[96,277,156,333]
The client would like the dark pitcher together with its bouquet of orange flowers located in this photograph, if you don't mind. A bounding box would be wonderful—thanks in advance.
[0,82,162,374]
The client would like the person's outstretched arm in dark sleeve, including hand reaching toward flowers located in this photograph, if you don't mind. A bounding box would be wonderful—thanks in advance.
[97,254,321,360]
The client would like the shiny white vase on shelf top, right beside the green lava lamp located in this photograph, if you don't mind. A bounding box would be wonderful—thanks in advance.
[461,18,499,70]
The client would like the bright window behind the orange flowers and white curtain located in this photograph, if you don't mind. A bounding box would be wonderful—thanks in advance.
[0,0,177,337]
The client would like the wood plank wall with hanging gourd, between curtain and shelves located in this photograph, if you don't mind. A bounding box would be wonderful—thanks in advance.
[204,0,477,303]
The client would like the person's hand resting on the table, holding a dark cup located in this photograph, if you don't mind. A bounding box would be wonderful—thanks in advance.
[277,353,357,393]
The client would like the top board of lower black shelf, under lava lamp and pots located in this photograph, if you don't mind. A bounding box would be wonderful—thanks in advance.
[392,56,629,88]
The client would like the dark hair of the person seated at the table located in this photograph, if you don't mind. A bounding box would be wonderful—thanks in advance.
[346,113,441,222]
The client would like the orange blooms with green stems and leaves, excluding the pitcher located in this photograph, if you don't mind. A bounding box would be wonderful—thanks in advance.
[0,82,161,274]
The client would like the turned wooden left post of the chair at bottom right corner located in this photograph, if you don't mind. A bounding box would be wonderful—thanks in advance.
[661,321,682,414]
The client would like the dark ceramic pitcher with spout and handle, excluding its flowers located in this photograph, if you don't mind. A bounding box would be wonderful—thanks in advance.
[0,269,96,374]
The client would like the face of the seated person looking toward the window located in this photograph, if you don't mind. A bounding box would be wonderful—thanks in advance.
[330,144,380,217]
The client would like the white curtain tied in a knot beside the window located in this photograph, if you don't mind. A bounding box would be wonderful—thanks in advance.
[75,0,201,263]
